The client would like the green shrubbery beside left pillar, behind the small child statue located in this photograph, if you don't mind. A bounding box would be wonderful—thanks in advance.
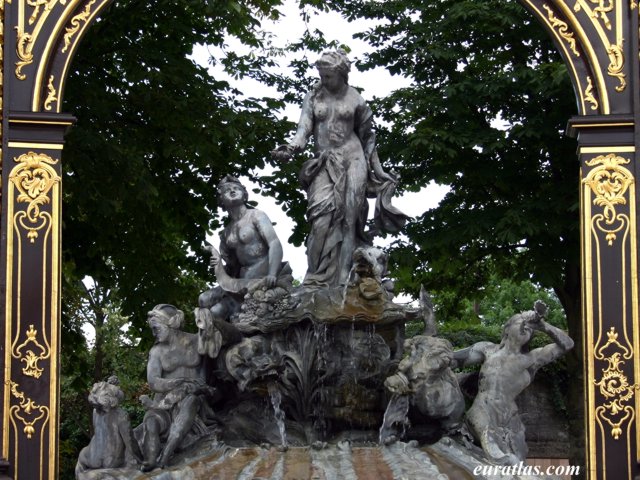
[60,279,148,479]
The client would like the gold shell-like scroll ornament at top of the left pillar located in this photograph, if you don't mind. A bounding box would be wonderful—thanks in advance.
[9,152,60,243]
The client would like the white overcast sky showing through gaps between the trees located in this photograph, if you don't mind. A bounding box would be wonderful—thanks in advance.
[194,1,447,280]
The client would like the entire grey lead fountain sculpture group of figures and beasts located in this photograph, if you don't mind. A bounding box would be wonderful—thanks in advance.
[77,51,573,479]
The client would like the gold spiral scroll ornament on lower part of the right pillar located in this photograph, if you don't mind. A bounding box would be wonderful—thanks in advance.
[594,327,636,440]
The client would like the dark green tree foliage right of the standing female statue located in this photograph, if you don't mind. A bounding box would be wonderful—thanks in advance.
[318,0,579,330]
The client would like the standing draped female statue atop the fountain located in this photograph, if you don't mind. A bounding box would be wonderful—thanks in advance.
[272,50,407,286]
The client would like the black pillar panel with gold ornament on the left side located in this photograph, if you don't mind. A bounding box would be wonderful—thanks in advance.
[3,147,61,478]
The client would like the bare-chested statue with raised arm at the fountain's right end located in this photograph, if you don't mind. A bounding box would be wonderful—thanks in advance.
[454,300,573,465]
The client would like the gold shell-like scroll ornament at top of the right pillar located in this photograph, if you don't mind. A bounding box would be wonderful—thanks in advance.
[583,153,634,246]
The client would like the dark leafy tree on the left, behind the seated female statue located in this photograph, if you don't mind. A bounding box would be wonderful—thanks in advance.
[63,0,286,335]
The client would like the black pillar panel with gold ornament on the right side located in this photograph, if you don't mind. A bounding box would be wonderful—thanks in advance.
[581,146,640,480]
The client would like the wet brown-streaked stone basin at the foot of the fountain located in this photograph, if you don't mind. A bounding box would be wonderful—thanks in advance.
[75,438,557,480]
